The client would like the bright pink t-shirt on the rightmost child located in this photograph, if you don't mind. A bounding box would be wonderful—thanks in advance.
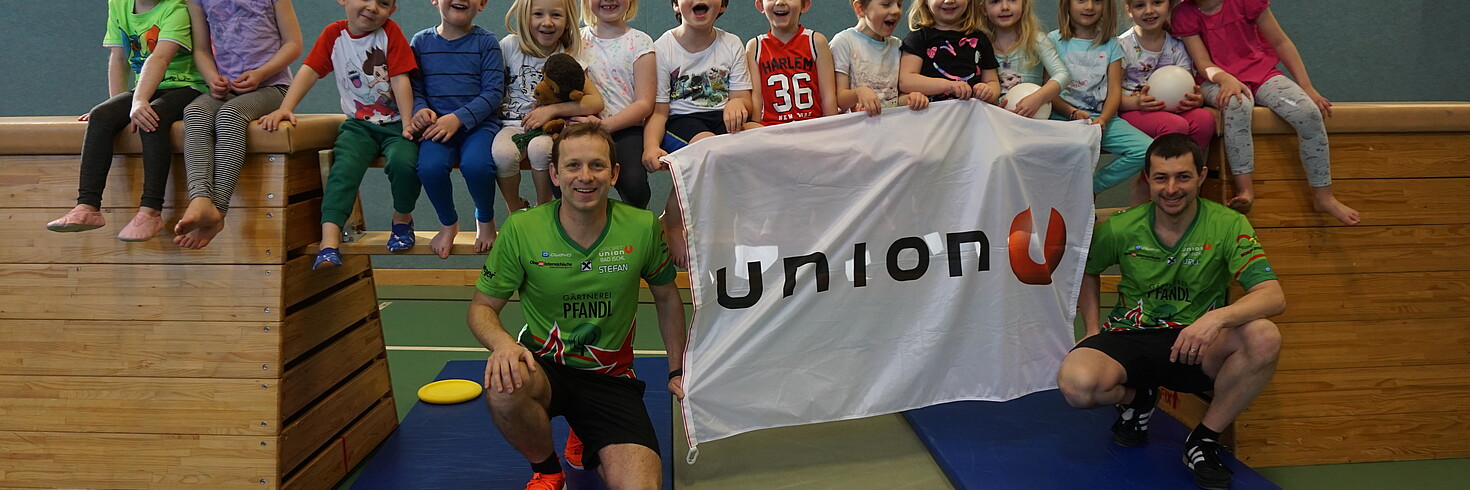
[1169,0,1282,93]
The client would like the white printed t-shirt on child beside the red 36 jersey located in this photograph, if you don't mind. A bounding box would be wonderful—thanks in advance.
[653,28,751,115]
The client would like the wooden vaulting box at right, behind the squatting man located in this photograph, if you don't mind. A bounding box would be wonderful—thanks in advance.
[1160,103,1470,466]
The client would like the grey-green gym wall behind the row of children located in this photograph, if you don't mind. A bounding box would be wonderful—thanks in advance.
[0,0,1470,116]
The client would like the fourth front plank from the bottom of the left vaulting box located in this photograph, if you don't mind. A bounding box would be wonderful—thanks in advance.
[0,263,282,322]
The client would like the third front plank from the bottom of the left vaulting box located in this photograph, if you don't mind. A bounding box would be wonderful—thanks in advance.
[0,319,281,378]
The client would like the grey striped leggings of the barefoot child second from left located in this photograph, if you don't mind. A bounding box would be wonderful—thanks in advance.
[184,85,287,213]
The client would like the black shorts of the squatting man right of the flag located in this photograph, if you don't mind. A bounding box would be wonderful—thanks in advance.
[1072,328,1214,393]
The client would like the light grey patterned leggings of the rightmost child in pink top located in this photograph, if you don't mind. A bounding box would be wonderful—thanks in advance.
[1200,75,1332,187]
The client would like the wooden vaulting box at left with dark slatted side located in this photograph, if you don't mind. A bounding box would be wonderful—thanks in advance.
[0,115,397,489]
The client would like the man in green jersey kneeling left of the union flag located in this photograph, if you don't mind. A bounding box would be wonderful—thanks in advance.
[469,125,685,489]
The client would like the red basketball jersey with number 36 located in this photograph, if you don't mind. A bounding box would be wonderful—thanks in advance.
[756,28,822,125]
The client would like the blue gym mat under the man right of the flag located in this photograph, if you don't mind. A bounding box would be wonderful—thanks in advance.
[904,390,1279,490]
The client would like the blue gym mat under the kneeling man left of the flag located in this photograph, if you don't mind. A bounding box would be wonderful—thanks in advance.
[353,358,673,490]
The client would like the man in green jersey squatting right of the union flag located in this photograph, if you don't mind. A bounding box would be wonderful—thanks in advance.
[1057,134,1286,489]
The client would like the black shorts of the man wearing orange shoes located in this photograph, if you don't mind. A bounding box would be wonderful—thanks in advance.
[537,356,659,469]
